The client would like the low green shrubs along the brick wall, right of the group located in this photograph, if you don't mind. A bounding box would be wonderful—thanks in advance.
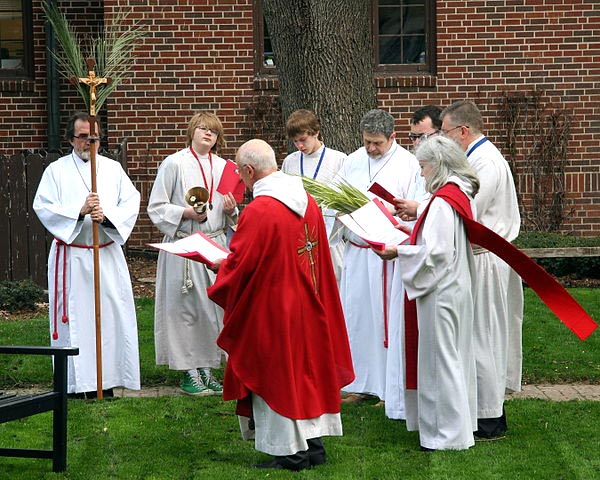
[513,232,600,278]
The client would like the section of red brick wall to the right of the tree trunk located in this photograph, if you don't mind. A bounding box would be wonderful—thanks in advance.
[378,0,600,235]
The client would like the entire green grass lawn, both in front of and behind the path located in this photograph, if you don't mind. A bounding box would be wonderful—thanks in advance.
[0,289,600,480]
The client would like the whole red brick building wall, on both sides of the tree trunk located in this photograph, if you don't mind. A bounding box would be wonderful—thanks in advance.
[0,0,600,246]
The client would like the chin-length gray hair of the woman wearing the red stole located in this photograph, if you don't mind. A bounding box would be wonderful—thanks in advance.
[415,136,479,197]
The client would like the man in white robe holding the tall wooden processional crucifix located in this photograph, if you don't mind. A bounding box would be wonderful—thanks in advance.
[33,60,140,399]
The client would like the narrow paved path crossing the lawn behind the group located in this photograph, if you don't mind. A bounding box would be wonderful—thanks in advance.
[108,384,600,402]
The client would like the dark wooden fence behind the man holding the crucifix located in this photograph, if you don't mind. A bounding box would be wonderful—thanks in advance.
[0,140,127,288]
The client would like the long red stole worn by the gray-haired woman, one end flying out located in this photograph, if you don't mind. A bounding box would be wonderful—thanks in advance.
[404,183,598,390]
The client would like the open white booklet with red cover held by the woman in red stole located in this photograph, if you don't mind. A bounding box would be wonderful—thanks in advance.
[338,198,408,250]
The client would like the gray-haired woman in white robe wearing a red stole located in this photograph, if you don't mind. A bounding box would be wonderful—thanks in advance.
[382,137,479,450]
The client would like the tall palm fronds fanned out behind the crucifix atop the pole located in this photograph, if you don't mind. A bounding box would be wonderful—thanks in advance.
[42,0,147,114]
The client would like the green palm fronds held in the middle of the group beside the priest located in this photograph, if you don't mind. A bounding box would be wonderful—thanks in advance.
[302,177,369,213]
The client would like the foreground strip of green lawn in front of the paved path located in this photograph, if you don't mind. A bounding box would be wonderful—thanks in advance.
[0,397,600,480]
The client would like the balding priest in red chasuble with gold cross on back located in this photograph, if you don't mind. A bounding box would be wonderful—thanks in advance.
[208,139,354,470]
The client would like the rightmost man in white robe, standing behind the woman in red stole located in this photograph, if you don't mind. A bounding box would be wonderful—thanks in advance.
[441,100,523,439]
